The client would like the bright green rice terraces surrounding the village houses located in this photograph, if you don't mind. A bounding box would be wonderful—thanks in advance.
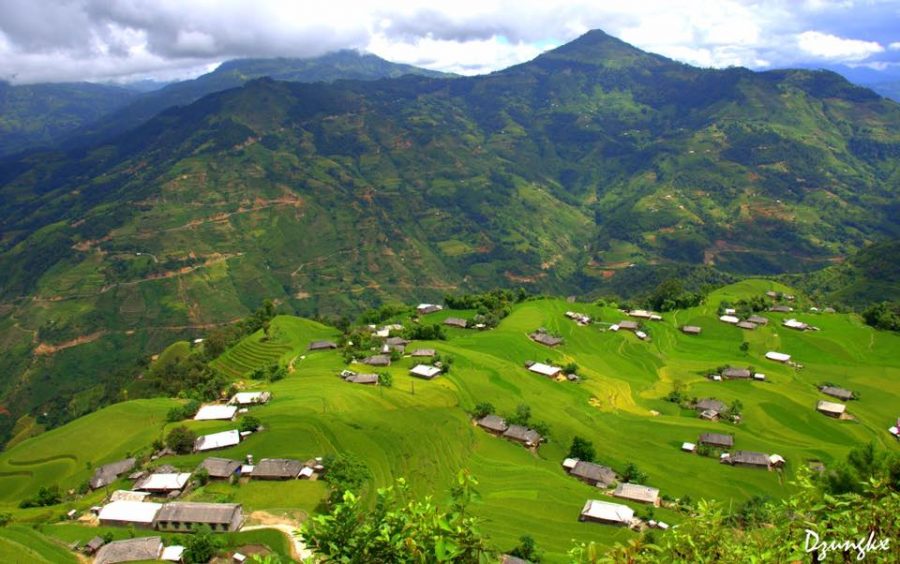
[0,280,900,562]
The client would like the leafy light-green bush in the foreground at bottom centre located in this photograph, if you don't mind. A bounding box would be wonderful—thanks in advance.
[300,471,493,563]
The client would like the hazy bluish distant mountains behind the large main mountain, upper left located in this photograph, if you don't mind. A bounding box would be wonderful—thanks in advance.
[0,50,447,157]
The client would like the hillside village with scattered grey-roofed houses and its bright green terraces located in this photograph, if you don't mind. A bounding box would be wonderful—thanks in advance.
[0,281,900,563]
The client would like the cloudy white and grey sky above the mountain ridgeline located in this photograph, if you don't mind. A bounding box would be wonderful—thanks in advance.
[0,0,900,83]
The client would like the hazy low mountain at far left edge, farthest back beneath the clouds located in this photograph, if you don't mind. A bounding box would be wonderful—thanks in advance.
[0,81,137,156]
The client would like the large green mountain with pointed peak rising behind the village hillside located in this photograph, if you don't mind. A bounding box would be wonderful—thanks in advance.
[0,31,900,446]
